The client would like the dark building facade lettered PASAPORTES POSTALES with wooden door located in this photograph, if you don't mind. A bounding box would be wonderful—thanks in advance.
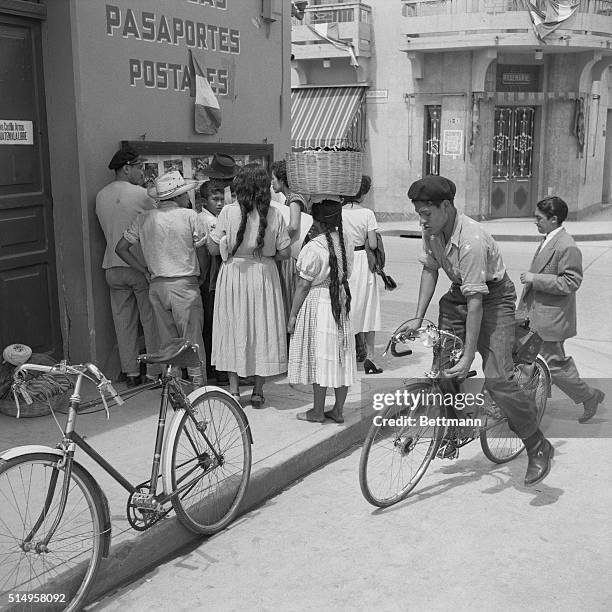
[0,0,291,373]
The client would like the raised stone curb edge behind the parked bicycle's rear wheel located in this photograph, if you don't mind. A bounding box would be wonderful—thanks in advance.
[88,409,370,603]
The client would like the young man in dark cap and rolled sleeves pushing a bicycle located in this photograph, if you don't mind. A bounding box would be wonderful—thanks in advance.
[399,175,554,486]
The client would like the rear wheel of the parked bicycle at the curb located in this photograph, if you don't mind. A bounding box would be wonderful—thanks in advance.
[167,391,252,535]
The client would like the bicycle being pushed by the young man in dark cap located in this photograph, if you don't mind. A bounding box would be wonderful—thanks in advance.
[359,319,551,508]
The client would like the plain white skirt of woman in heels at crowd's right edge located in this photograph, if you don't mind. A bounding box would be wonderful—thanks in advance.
[349,251,382,334]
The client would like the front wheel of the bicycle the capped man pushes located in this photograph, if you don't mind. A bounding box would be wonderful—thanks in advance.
[359,382,446,508]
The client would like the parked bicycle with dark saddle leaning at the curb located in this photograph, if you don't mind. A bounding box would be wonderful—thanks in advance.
[0,339,252,611]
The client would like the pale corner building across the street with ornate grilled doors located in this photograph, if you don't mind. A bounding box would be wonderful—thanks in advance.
[292,0,612,219]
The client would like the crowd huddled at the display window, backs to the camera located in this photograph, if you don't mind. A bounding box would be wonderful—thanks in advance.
[96,149,382,423]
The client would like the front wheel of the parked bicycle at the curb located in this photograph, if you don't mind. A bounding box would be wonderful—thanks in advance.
[0,452,105,612]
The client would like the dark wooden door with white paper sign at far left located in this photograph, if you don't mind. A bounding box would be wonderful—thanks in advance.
[0,13,61,354]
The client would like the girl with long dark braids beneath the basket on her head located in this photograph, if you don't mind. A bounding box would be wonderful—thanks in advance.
[287,200,357,423]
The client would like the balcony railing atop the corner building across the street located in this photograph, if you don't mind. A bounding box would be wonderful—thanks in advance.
[402,0,612,17]
